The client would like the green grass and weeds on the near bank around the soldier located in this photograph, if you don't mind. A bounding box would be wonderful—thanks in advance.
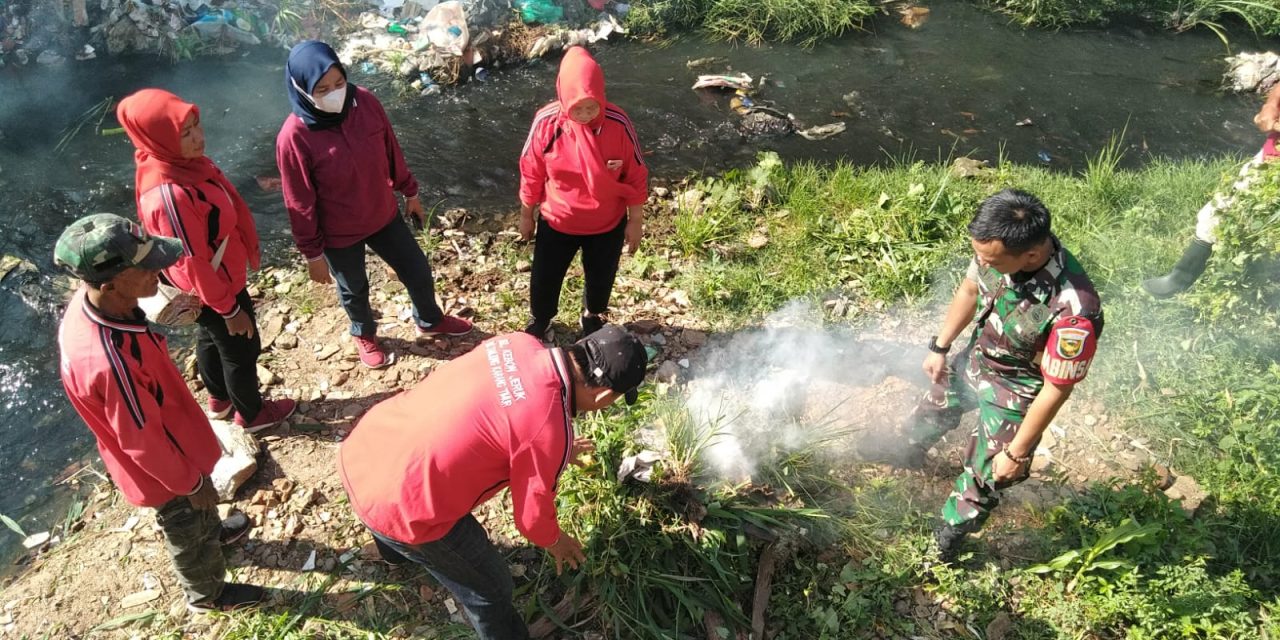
[10,152,1280,640]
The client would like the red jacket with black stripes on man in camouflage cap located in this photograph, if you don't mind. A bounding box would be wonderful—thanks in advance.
[58,288,221,507]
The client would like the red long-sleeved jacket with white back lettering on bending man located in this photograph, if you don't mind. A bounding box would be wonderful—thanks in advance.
[338,333,573,547]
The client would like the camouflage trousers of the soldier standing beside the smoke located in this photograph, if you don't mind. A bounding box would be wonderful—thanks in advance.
[908,346,1043,532]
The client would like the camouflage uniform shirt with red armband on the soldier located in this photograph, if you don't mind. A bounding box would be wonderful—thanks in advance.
[965,232,1102,399]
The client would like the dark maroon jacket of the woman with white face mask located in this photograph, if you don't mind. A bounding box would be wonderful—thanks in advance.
[275,87,417,260]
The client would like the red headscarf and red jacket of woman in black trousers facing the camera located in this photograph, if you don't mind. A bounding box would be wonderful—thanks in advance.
[520,46,649,236]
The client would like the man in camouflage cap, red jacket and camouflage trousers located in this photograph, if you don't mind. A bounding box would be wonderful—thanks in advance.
[54,214,262,612]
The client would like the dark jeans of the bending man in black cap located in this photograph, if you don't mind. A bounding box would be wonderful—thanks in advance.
[372,513,529,640]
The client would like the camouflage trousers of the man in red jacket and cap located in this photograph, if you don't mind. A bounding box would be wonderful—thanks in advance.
[156,495,227,604]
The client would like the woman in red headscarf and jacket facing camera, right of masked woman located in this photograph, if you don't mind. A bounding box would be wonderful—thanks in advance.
[520,46,649,338]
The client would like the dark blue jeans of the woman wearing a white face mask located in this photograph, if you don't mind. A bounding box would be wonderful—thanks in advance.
[324,215,444,338]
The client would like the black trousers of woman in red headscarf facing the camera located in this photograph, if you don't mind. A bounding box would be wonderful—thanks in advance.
[529,216,627,324]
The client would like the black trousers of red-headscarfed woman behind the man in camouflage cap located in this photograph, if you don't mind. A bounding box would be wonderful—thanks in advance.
[196,289,262,422]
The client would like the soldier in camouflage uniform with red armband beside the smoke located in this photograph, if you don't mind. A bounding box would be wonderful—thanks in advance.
[908,189,1102,561]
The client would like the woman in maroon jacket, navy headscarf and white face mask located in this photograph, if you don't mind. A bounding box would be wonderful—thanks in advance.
[275,40,471,369]
